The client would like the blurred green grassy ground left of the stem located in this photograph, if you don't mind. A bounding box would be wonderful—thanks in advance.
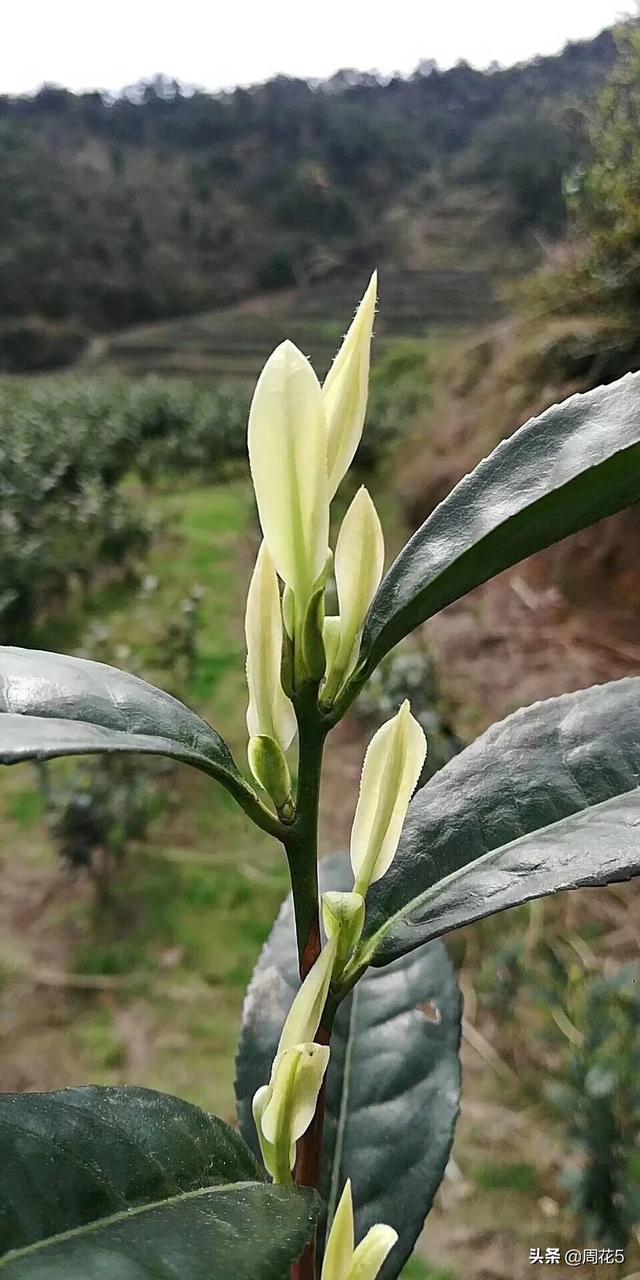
[1,479,287,1119]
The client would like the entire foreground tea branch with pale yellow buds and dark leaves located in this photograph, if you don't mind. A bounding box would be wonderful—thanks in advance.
[0,280,640,1280]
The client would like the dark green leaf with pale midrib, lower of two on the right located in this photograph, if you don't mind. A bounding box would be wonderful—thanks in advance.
[362,678,640,965]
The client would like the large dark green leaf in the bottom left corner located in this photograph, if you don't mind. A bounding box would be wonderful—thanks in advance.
[0,1087,314,1280]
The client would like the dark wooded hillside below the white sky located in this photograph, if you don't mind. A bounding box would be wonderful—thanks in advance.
[0,32,614,369]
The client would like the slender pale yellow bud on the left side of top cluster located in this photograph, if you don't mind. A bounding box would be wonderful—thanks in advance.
[244,543,296,747]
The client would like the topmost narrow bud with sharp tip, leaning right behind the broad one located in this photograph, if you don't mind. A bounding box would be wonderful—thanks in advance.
[323,271,378,500]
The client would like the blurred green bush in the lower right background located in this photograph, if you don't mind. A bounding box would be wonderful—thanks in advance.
[476,932,640,1247]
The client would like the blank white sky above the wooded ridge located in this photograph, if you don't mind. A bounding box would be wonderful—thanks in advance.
[0,0,635,93]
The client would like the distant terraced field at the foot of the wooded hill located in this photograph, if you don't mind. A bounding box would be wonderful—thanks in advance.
[86,268,500,379]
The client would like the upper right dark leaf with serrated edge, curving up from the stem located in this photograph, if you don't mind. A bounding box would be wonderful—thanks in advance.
[361,374,640,672]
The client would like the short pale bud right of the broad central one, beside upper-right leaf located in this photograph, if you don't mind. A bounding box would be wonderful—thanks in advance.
[323,485,384,701]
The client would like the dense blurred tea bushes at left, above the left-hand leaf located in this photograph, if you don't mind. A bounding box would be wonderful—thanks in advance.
[0,379,247,643]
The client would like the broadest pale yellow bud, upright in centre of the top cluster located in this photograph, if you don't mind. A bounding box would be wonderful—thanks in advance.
[248,342,329,616]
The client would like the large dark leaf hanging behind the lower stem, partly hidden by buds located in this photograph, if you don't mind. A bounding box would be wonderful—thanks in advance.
[237,855,460,1280]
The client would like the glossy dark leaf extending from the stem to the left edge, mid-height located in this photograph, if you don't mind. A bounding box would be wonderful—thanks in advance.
[0,646,257,797]
